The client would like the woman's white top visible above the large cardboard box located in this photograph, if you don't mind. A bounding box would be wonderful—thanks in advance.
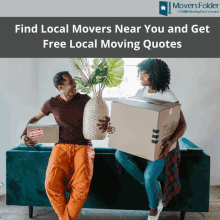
[135,86,178,102]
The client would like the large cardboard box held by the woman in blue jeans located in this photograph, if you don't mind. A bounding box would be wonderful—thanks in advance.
[109,97,181,161]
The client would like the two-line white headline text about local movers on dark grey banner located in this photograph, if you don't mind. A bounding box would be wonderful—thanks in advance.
[15,24,210,51]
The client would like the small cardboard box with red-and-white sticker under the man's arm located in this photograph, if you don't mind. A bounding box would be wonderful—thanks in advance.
[27,124,59,143]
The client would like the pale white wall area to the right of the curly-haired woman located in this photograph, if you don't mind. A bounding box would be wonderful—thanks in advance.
[163,58,220,185]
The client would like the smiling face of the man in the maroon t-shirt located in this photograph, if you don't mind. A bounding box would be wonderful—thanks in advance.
[60,74,76,96]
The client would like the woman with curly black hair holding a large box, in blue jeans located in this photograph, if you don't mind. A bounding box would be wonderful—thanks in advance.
[100,59,186,220]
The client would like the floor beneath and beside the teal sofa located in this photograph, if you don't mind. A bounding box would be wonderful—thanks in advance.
[0,186,220,220]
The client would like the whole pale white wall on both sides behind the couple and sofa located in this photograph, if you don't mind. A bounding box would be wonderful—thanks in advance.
[0,58,220,188]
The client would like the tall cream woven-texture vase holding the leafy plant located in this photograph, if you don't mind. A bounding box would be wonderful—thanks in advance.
[83,92,109,140]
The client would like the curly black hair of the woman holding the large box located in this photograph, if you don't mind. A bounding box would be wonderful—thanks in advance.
[137,59,170,92]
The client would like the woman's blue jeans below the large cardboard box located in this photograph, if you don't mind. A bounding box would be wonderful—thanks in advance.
[115,150,165,209]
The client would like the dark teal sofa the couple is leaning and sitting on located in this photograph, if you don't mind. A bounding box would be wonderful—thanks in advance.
[6,138,210,220]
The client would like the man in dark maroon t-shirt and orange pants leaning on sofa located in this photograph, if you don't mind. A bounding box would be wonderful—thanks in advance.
[22,72,95,220]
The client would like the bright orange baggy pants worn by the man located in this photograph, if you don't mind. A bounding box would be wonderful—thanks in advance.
[45,144,95,220]
